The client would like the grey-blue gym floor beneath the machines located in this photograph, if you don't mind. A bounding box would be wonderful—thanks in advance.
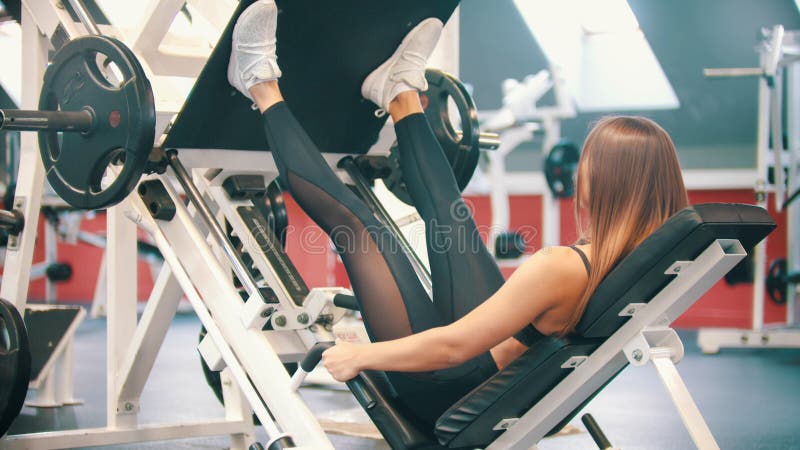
[10,314,800,450]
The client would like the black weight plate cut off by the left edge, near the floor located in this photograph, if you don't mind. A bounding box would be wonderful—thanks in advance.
[0,299,31,437]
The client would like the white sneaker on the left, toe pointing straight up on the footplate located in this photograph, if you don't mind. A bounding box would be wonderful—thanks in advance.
[228,0,281,100]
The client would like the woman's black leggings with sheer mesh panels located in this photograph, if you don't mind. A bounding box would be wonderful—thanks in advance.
[263,103,504,426]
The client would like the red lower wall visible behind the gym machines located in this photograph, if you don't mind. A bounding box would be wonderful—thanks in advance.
[4,190,786,327]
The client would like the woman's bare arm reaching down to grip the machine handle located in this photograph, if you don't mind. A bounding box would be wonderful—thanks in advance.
[323,247,586,381]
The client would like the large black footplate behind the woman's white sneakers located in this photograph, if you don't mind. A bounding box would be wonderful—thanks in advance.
[165,0,458,153]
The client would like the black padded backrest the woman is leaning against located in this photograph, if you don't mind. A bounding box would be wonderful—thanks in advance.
[435,204,775,447]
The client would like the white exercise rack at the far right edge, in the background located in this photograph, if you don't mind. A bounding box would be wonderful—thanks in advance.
[697,25,800,353]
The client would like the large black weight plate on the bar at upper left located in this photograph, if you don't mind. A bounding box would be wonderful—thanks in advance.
[39,36,155,209]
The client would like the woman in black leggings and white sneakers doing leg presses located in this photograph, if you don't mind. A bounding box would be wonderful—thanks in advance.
[228,0,687,421]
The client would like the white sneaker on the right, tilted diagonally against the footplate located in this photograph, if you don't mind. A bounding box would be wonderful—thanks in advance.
[361,18,444,112]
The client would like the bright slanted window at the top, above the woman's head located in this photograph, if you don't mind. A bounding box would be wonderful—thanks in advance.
[514,0,676,111]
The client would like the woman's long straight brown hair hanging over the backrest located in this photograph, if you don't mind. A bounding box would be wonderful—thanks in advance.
[563,117,688,333]
